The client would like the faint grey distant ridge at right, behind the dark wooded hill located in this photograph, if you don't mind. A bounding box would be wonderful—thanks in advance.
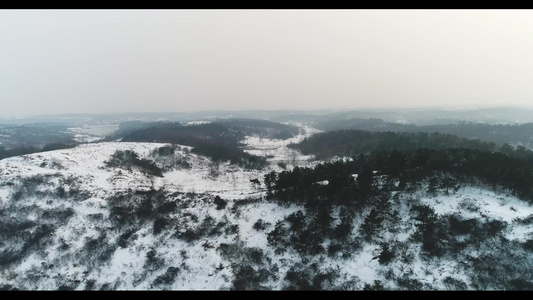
[315,118,533,147]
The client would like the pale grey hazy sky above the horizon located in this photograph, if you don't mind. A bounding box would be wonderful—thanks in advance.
[0,10,533,116]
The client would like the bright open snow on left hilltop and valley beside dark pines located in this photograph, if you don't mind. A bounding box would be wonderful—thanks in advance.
[0,128,315,203]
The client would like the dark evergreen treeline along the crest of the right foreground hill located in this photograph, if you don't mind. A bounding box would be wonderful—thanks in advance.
[265,148,533,207]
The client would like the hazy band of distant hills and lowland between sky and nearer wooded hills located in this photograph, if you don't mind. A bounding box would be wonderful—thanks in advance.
[0,108,533,152]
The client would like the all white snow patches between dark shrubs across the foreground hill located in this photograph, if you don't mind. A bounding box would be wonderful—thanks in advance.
[0,127,533,290]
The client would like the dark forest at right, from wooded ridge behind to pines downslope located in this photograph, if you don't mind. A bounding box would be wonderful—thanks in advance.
[264,130,533,264]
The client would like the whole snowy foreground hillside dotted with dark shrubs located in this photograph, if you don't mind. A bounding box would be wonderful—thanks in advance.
[0,128,533,290]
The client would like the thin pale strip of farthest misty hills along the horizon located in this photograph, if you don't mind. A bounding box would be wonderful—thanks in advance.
[0,107,533,125]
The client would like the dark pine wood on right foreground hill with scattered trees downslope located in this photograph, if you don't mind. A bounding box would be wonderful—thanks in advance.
[264,148,533,289]
